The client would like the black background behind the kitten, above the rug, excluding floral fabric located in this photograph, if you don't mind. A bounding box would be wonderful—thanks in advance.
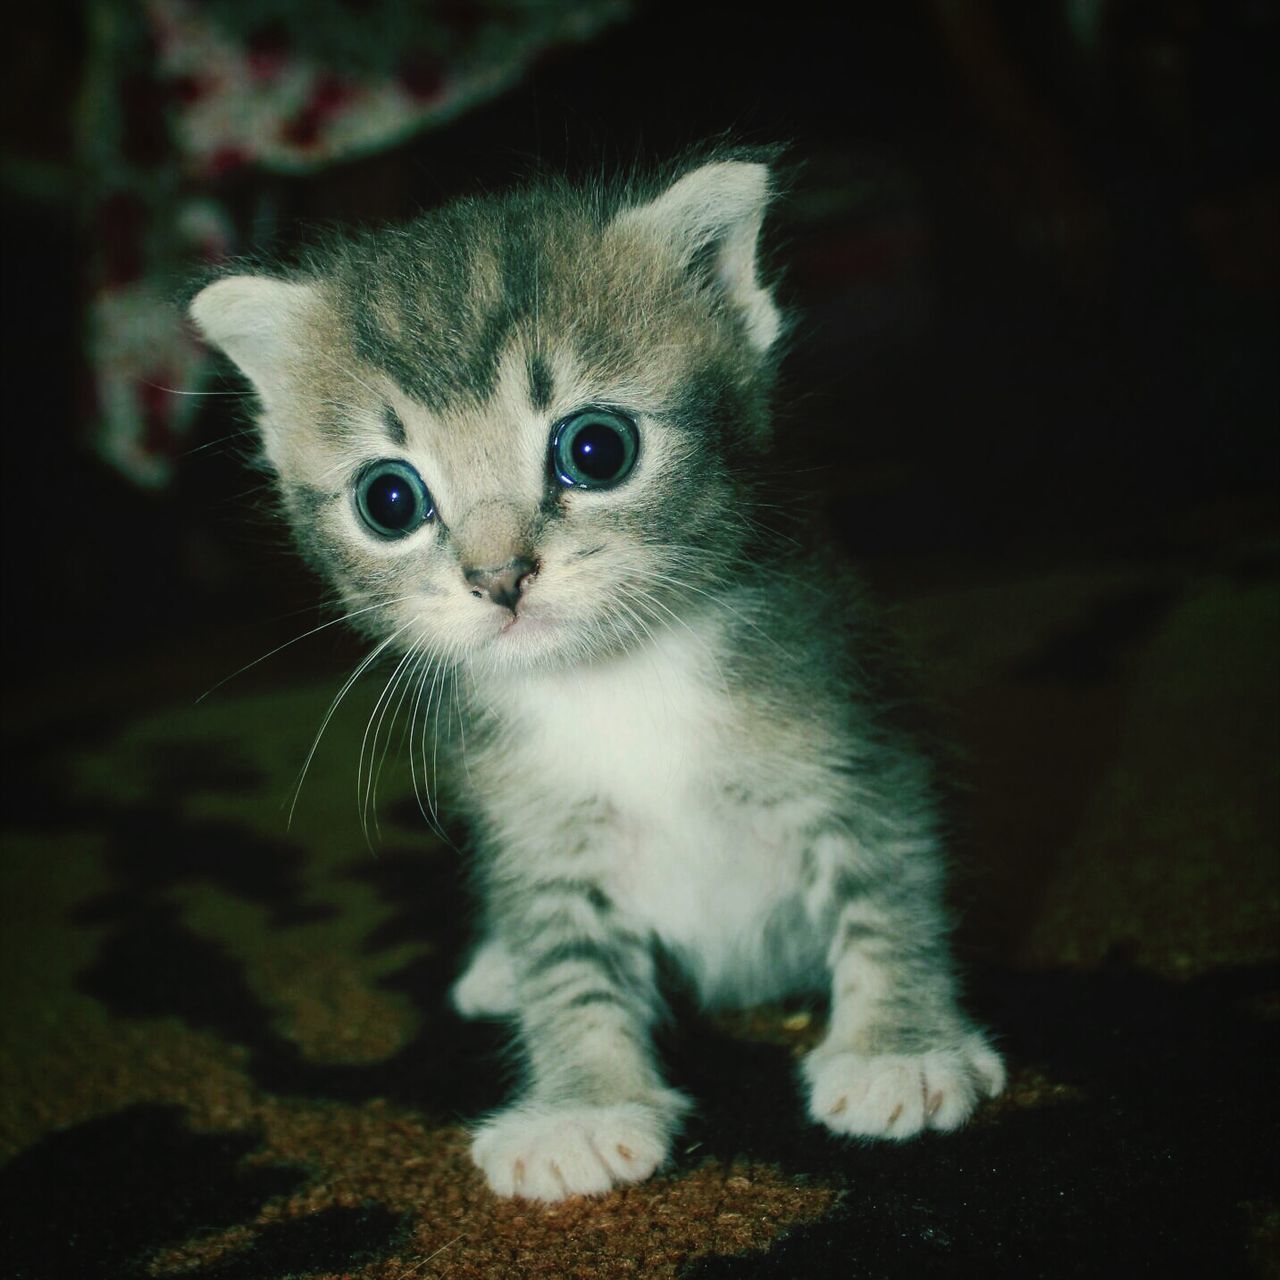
[3,0,1280,687]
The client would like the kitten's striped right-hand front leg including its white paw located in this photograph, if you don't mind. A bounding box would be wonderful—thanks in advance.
[803,814,1005,1139]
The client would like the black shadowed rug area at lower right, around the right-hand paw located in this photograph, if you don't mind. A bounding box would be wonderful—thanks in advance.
[676,964,1280,1280]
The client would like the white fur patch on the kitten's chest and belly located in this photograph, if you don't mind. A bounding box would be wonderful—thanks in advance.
[488,635,818,1000]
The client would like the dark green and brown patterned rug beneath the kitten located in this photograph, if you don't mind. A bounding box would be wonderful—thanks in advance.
[0,532,1280,1280]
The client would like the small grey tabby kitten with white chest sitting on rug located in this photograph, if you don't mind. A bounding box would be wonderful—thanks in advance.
[192,155,1004,1201]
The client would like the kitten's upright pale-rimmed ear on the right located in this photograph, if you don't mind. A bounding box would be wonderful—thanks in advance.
[617,160,781,352]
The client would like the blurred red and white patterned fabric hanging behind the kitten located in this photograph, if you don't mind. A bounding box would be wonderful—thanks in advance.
[76,0,627,488]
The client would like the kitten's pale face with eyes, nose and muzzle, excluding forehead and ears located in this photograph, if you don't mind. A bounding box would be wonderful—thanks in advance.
[282,325,740,666]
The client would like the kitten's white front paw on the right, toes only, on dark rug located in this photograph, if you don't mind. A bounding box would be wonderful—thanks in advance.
[804,1034,1005,1140]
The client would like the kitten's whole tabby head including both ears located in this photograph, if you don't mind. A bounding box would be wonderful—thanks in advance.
[191,159,780,668]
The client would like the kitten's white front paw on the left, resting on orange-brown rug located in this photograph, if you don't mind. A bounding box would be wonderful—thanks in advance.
[471,1102,682,1201]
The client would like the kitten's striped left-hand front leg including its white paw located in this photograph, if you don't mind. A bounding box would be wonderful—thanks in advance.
[471,881,687,1201]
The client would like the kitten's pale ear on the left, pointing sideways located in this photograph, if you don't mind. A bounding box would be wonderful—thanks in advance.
[189,275,317,404]
